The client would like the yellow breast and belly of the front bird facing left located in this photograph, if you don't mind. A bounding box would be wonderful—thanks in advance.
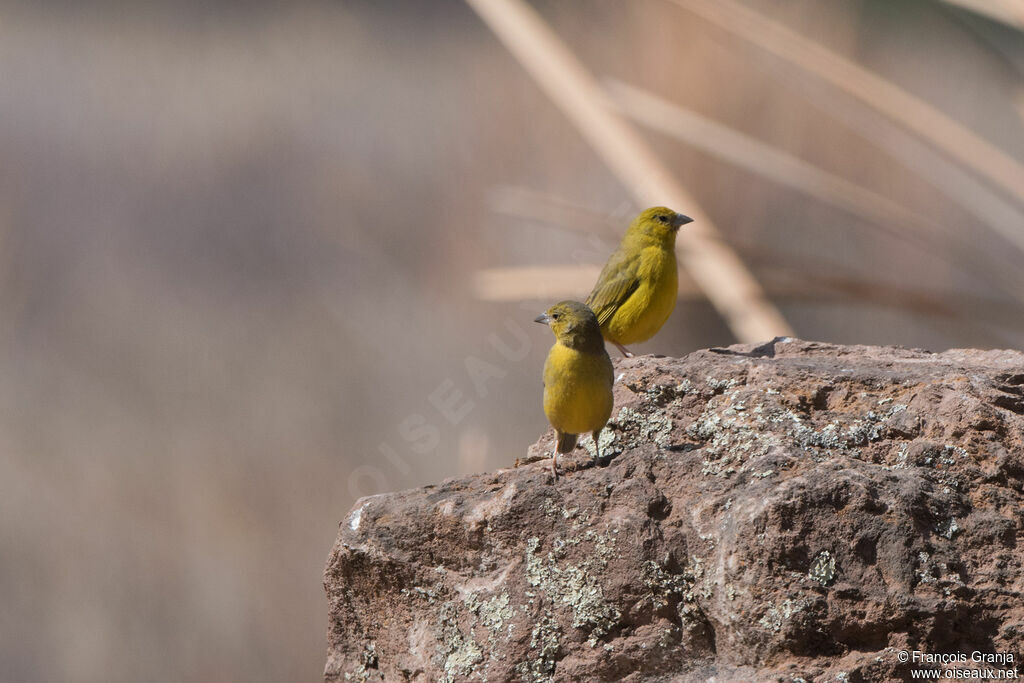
[544,343,614,434]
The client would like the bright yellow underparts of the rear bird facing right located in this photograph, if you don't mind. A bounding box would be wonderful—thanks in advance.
[602,247,679,345]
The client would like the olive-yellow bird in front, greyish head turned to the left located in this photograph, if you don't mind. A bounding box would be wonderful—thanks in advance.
[535,301,614,479]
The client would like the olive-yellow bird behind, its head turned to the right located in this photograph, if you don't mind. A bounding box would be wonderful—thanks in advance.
[587,207,693,357]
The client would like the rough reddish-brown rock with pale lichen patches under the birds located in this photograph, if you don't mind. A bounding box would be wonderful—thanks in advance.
[325,339,1024,681]
